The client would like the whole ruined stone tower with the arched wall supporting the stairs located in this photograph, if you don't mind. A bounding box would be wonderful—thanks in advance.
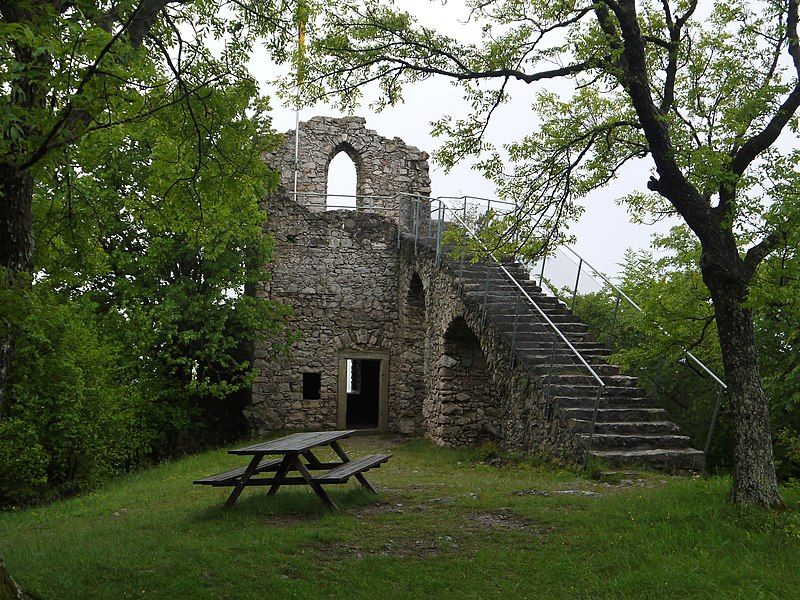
[245,117,702,468]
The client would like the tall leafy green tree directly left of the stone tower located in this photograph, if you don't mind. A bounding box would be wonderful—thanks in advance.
[25,74,291,468]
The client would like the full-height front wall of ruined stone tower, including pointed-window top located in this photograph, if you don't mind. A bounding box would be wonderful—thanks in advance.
[250,117,430,434]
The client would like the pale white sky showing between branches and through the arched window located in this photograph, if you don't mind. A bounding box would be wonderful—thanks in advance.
[251,0,678,279]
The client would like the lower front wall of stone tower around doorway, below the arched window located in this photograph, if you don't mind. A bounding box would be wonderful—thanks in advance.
[246,199,398,432]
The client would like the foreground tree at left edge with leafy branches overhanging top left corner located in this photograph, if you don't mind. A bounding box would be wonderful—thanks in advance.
[0,0,300,597]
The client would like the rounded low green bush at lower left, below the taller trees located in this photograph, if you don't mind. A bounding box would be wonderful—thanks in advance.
[0,286,151,503]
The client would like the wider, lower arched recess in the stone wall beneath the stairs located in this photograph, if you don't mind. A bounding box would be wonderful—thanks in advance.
[427,315,499,446]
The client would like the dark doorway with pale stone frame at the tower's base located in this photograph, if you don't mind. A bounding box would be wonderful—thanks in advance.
[339,355,388,430]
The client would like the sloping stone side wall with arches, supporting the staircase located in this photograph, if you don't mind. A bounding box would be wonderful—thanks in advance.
[400,240,578,458]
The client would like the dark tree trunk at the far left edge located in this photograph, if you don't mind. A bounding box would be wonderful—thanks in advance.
[0,164,33,417]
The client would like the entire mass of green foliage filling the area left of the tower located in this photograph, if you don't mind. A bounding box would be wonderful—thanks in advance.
[0,0,302,503]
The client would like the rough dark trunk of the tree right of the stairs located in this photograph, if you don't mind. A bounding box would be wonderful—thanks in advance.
[703,264,781,506]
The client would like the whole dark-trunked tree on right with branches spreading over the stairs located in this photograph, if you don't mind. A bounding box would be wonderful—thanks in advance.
[298,0,800,506]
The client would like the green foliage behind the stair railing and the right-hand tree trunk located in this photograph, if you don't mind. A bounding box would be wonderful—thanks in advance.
[575,228,800,480]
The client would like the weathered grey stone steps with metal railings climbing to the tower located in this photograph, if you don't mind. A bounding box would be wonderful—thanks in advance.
[444,258,703,471]
